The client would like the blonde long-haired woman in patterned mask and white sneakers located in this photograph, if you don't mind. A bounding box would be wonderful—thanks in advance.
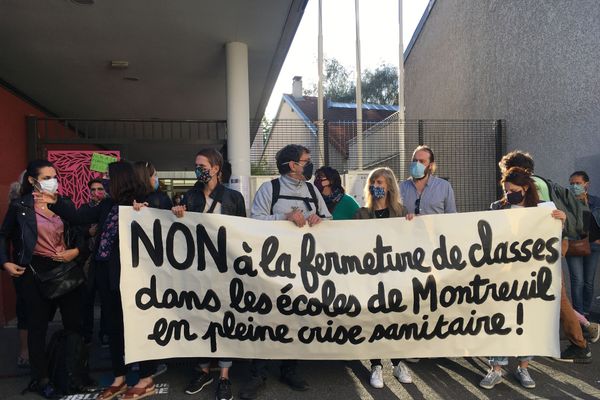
[354,167,414,389]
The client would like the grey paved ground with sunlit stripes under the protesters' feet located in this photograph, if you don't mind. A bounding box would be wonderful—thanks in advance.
[0,262,600,400]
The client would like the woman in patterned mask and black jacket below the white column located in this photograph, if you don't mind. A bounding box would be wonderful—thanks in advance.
[172,149,246,400]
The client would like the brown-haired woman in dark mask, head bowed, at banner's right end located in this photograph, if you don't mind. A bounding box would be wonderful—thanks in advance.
[479,167,567,389]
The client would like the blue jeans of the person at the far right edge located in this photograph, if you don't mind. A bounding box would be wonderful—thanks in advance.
[567,243,600,314]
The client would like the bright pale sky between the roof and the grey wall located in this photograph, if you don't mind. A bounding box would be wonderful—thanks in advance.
[265,0,429,119]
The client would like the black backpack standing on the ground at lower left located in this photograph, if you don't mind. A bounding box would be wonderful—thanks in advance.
[46,330,90,395]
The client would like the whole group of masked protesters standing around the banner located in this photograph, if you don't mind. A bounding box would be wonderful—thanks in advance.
[0,144,600,400]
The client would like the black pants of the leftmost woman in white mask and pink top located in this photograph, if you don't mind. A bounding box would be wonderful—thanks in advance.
[19,256,81,380]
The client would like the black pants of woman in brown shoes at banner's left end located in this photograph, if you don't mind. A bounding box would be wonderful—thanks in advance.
[100,286,156,378]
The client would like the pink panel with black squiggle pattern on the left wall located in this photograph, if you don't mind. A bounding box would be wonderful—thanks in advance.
[48,150,120,207]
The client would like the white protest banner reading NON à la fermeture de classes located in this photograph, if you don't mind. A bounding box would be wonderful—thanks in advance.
[119,207,561,363]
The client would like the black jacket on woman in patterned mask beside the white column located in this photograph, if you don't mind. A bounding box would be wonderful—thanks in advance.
[181,182,246,217]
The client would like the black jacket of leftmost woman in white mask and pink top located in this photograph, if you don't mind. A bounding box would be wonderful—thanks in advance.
[0,194,89,267]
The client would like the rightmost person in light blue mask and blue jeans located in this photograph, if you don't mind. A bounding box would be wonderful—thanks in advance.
[566,171,600,322]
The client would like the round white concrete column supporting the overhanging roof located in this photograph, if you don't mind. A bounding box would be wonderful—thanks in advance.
[225,42,250,177]
